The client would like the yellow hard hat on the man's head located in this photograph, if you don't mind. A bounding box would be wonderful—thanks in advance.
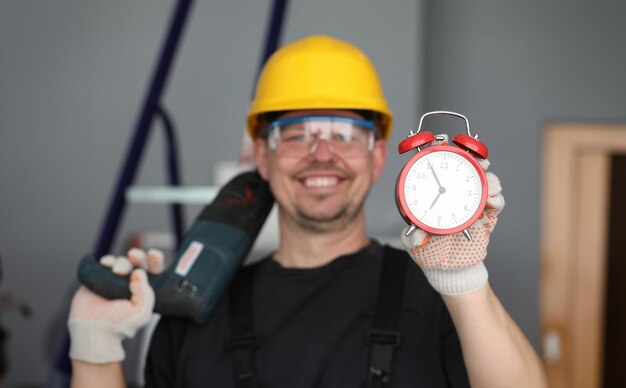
[247,35,393,139]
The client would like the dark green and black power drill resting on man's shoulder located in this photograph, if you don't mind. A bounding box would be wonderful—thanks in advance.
[78,171,274,324]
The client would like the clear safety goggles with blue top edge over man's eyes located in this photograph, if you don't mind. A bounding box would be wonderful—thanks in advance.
[268,116,374,158]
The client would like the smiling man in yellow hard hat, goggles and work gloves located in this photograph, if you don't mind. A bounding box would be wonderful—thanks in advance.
[69,36,546,388]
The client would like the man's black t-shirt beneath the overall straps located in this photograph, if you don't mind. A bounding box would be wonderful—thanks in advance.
[145,242,469,388]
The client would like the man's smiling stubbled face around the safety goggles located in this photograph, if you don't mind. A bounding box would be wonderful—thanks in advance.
[255,109,386,233]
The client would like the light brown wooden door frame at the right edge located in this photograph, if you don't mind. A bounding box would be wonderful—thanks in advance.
[540,122,626,388]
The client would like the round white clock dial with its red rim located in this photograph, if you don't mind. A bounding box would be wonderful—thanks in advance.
[396,146,487,234]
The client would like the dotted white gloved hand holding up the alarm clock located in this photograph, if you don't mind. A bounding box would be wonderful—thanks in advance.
[400,139,504,295]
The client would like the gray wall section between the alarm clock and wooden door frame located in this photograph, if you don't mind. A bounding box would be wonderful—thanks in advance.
[424,0,626,344]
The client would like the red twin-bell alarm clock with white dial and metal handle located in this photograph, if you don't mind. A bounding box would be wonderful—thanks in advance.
[396,111,489,240]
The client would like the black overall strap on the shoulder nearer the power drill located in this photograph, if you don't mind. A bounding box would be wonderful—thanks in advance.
[226,265,259,388]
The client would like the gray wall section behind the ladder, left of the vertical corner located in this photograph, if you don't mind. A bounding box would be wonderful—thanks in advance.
[0,0,423,386]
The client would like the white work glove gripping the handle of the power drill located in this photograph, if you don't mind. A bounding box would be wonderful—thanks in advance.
[67,249,163,364]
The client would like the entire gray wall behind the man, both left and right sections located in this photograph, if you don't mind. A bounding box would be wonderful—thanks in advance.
[0,0,626,385]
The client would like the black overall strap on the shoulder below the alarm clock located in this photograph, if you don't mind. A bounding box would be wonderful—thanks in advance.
[366,246,407,388]
